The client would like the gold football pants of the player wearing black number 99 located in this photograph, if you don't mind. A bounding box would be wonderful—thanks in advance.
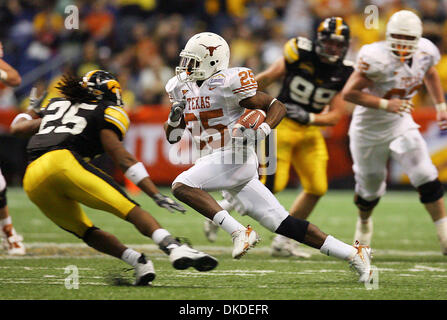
[261,118,329,196]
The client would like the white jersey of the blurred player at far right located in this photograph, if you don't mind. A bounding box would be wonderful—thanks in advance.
[349,38,440,143]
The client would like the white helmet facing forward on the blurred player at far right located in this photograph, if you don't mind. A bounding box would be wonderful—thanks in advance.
[386,10,422,60]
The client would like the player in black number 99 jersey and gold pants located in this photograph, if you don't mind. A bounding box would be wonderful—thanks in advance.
[205,17,353,256]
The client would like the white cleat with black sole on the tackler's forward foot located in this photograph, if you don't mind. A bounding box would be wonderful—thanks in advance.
[169,244,218,271]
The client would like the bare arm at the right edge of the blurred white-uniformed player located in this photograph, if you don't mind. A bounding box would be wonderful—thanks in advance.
[424,67,447,130]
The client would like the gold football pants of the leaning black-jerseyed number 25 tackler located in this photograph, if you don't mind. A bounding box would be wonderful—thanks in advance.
[23,149,136,238]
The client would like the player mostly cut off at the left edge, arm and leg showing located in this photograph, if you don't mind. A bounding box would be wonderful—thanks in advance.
[0,42,26,256]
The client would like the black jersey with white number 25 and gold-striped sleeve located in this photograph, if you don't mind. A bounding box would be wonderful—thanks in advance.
[27,98,130,161]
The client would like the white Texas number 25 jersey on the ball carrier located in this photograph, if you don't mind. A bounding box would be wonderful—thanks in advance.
[165,67,258,156]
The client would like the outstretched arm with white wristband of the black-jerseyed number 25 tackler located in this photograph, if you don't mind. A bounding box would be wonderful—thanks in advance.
[100,129,186,212]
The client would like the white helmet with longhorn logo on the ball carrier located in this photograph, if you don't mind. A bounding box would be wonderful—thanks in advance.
[175,32,230,82]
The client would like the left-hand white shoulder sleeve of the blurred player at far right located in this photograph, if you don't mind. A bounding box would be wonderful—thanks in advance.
[355,43,388,82]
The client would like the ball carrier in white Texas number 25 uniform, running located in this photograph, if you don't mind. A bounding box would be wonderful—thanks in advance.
[165,32,371,282]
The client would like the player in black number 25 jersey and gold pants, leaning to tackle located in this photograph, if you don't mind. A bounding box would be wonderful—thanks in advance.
[11,70,217,285]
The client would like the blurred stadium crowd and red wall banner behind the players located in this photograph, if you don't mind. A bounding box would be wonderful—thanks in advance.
[0,0,447,189]
